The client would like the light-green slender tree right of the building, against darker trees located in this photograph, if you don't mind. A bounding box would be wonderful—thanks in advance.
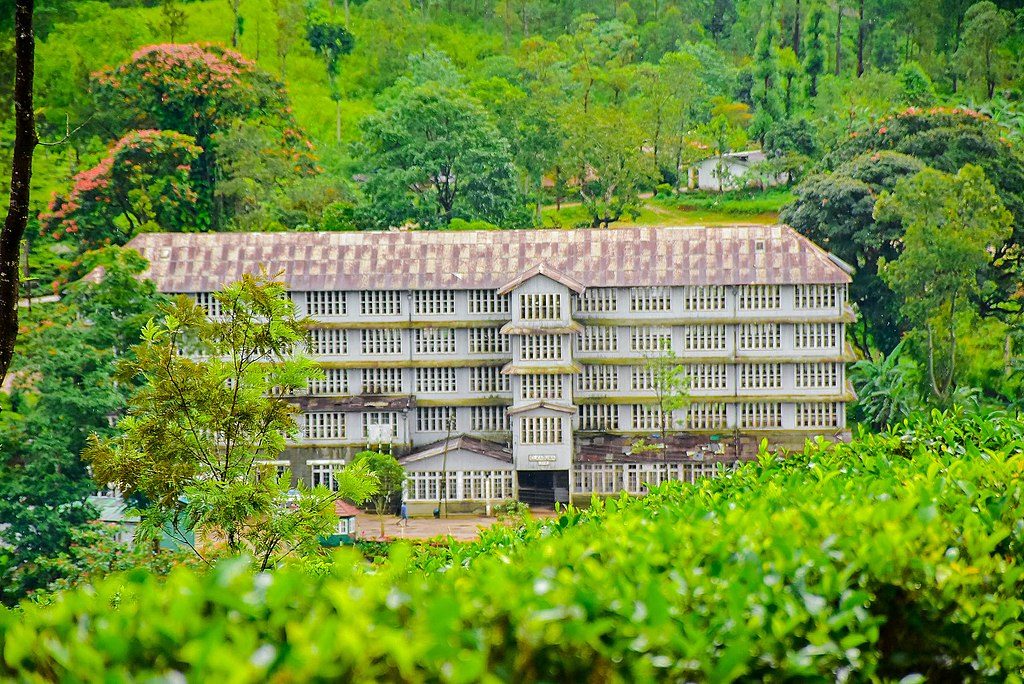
[874,165,1013,399]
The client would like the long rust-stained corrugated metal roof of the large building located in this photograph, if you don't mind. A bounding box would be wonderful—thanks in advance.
[128,225,850,292]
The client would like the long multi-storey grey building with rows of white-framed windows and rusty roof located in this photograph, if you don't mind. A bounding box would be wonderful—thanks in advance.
[123,225,853,513]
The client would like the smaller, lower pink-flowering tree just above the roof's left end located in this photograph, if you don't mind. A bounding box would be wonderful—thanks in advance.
[39,130,203,249]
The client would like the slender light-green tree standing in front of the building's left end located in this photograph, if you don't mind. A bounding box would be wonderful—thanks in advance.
[83,274,377,569]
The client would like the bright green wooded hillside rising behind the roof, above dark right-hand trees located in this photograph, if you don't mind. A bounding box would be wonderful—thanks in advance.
[2,0,1021,242]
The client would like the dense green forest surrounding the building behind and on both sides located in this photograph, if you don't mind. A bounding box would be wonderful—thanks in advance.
[0,0,1024,626]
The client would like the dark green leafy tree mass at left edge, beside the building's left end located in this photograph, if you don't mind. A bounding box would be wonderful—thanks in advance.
[0,250,160,603]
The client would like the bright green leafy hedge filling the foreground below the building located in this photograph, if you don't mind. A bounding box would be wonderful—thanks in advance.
[0,414,1024,682]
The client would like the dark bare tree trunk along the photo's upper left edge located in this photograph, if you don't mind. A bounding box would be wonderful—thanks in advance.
[0,0,39,381]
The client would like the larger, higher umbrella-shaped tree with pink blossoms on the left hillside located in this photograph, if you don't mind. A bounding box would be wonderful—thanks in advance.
[93,43,308,229]
